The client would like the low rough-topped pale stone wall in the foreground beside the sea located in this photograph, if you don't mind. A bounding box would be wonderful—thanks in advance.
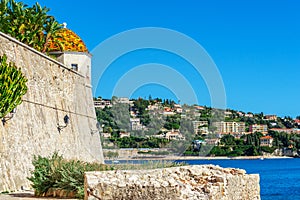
[85,165,260,200]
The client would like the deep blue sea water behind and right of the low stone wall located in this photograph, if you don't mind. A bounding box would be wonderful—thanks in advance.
[106,158,300,200]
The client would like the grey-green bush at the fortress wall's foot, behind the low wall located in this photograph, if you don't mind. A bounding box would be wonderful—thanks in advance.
[28,153,113,198]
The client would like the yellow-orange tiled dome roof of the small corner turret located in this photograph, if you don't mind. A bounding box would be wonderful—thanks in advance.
[48,28,88,52]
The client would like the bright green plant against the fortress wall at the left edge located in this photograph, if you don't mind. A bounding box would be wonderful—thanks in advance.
[0,55,27,118]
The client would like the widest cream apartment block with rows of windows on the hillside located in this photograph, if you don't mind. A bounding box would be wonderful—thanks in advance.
[213,121,246,134]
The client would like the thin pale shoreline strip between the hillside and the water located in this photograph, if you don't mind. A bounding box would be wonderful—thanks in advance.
[105,156,294,161]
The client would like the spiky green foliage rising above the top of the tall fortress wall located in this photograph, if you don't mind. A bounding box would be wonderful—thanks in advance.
[0,0,62,52]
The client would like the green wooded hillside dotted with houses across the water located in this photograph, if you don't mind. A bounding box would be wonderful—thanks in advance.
[94,97,300,156]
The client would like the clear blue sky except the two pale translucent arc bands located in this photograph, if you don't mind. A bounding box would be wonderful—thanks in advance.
[24,0,300,117]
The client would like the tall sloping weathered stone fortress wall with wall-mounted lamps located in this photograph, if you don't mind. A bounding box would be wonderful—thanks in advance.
[0,33,103,192]
